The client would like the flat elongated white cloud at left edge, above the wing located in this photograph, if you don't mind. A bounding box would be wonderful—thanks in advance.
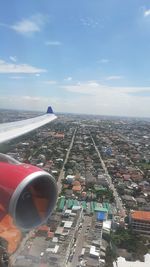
[0,59,46,74]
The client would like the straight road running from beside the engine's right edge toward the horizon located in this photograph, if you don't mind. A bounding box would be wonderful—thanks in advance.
[57,128,77,195]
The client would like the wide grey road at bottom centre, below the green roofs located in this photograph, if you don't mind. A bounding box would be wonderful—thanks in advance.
[67,216,92,267]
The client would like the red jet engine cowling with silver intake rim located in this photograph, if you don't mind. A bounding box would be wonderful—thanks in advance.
[0,154,57,230]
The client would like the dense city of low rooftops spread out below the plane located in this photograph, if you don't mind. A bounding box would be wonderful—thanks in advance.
[0,110,150,267]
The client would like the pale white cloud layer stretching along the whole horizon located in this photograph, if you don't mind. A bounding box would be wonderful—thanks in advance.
[0,81,150,117]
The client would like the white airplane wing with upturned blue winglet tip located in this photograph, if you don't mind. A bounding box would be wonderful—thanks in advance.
[0,107,57,143]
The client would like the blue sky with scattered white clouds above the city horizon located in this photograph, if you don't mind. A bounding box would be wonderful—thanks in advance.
[0,0,150,117]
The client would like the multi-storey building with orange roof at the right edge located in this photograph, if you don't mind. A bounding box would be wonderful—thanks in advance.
[130,210,150,234]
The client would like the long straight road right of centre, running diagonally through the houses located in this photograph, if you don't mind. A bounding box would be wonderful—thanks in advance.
[91,136,125,217]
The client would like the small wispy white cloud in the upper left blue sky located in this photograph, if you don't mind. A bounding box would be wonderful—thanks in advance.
[9,14,47,36]
